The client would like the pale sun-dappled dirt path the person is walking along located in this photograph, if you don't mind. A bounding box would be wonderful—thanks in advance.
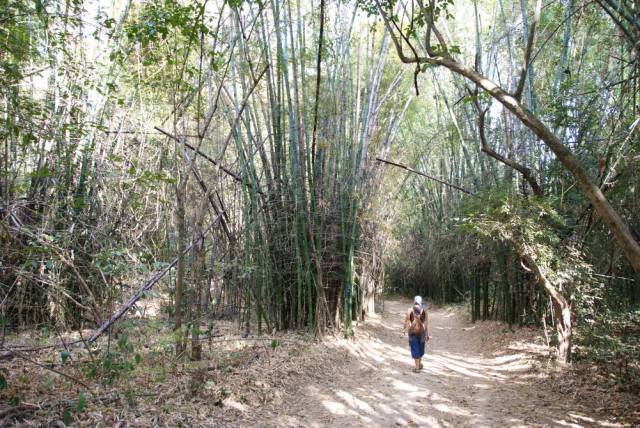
[261,301,616,427]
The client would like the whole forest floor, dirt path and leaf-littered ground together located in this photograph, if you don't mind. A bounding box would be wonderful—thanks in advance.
[0,300,640,427]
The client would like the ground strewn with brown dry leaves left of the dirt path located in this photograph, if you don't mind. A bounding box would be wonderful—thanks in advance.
[0,302,350,427]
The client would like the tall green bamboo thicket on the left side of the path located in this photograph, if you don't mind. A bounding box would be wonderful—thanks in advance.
[2,0,411,352]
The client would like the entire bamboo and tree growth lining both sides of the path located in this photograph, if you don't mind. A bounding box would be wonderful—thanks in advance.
[0,0,640,372]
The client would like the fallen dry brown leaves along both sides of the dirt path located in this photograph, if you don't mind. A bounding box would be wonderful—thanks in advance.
[0,302,640,427]
